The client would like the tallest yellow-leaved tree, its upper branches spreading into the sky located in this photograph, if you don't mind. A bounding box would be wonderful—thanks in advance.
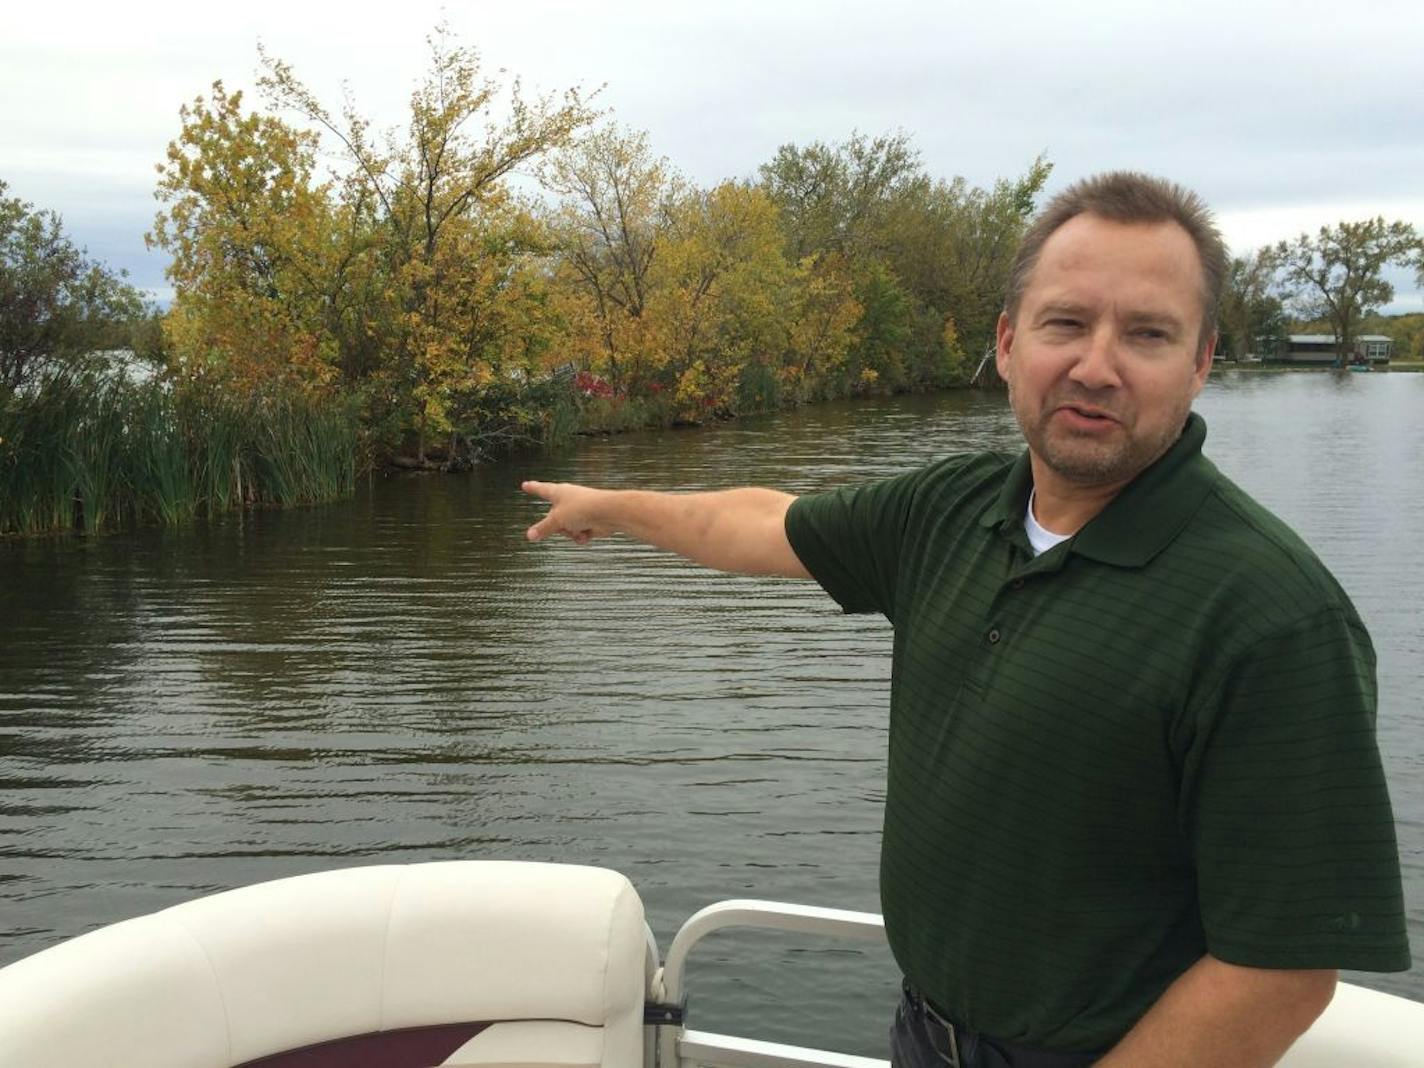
[261,26,595,464]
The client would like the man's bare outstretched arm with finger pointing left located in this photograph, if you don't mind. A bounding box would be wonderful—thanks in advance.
[523,481,810,578]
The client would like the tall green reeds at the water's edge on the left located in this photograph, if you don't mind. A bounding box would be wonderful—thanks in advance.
[0,369,356,535]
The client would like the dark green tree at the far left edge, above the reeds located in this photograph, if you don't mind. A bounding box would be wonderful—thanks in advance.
[0,181,148,390]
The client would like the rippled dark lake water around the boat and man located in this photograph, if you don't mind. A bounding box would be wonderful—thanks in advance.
[0,372,1424,1055]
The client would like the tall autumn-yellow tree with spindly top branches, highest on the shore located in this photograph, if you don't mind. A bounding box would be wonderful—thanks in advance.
[210,26,594,463]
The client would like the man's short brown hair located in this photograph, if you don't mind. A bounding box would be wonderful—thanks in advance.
[1004,171,1227,346]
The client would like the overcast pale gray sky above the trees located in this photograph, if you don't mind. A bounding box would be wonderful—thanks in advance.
[0,0,1424,312]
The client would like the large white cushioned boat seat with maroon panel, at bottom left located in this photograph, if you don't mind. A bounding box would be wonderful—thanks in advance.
[0,860,655,1068]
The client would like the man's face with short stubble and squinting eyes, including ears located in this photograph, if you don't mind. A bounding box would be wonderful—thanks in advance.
[998,215,1216,486]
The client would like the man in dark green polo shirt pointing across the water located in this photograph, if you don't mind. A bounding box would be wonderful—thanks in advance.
[524,174,1408,1068]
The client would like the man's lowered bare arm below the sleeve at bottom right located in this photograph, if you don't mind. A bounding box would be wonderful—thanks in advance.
[1098,956,1336,1068]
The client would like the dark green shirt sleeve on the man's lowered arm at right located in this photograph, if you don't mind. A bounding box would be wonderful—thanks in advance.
[1183,607,1410,971]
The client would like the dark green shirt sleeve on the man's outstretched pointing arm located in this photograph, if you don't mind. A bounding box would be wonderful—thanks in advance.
[786,471,924,622]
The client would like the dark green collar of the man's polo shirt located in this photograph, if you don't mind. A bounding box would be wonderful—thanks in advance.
[980,412,1218,567]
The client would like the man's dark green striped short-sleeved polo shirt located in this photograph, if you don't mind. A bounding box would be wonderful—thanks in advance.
[786,414,1410,1051]
